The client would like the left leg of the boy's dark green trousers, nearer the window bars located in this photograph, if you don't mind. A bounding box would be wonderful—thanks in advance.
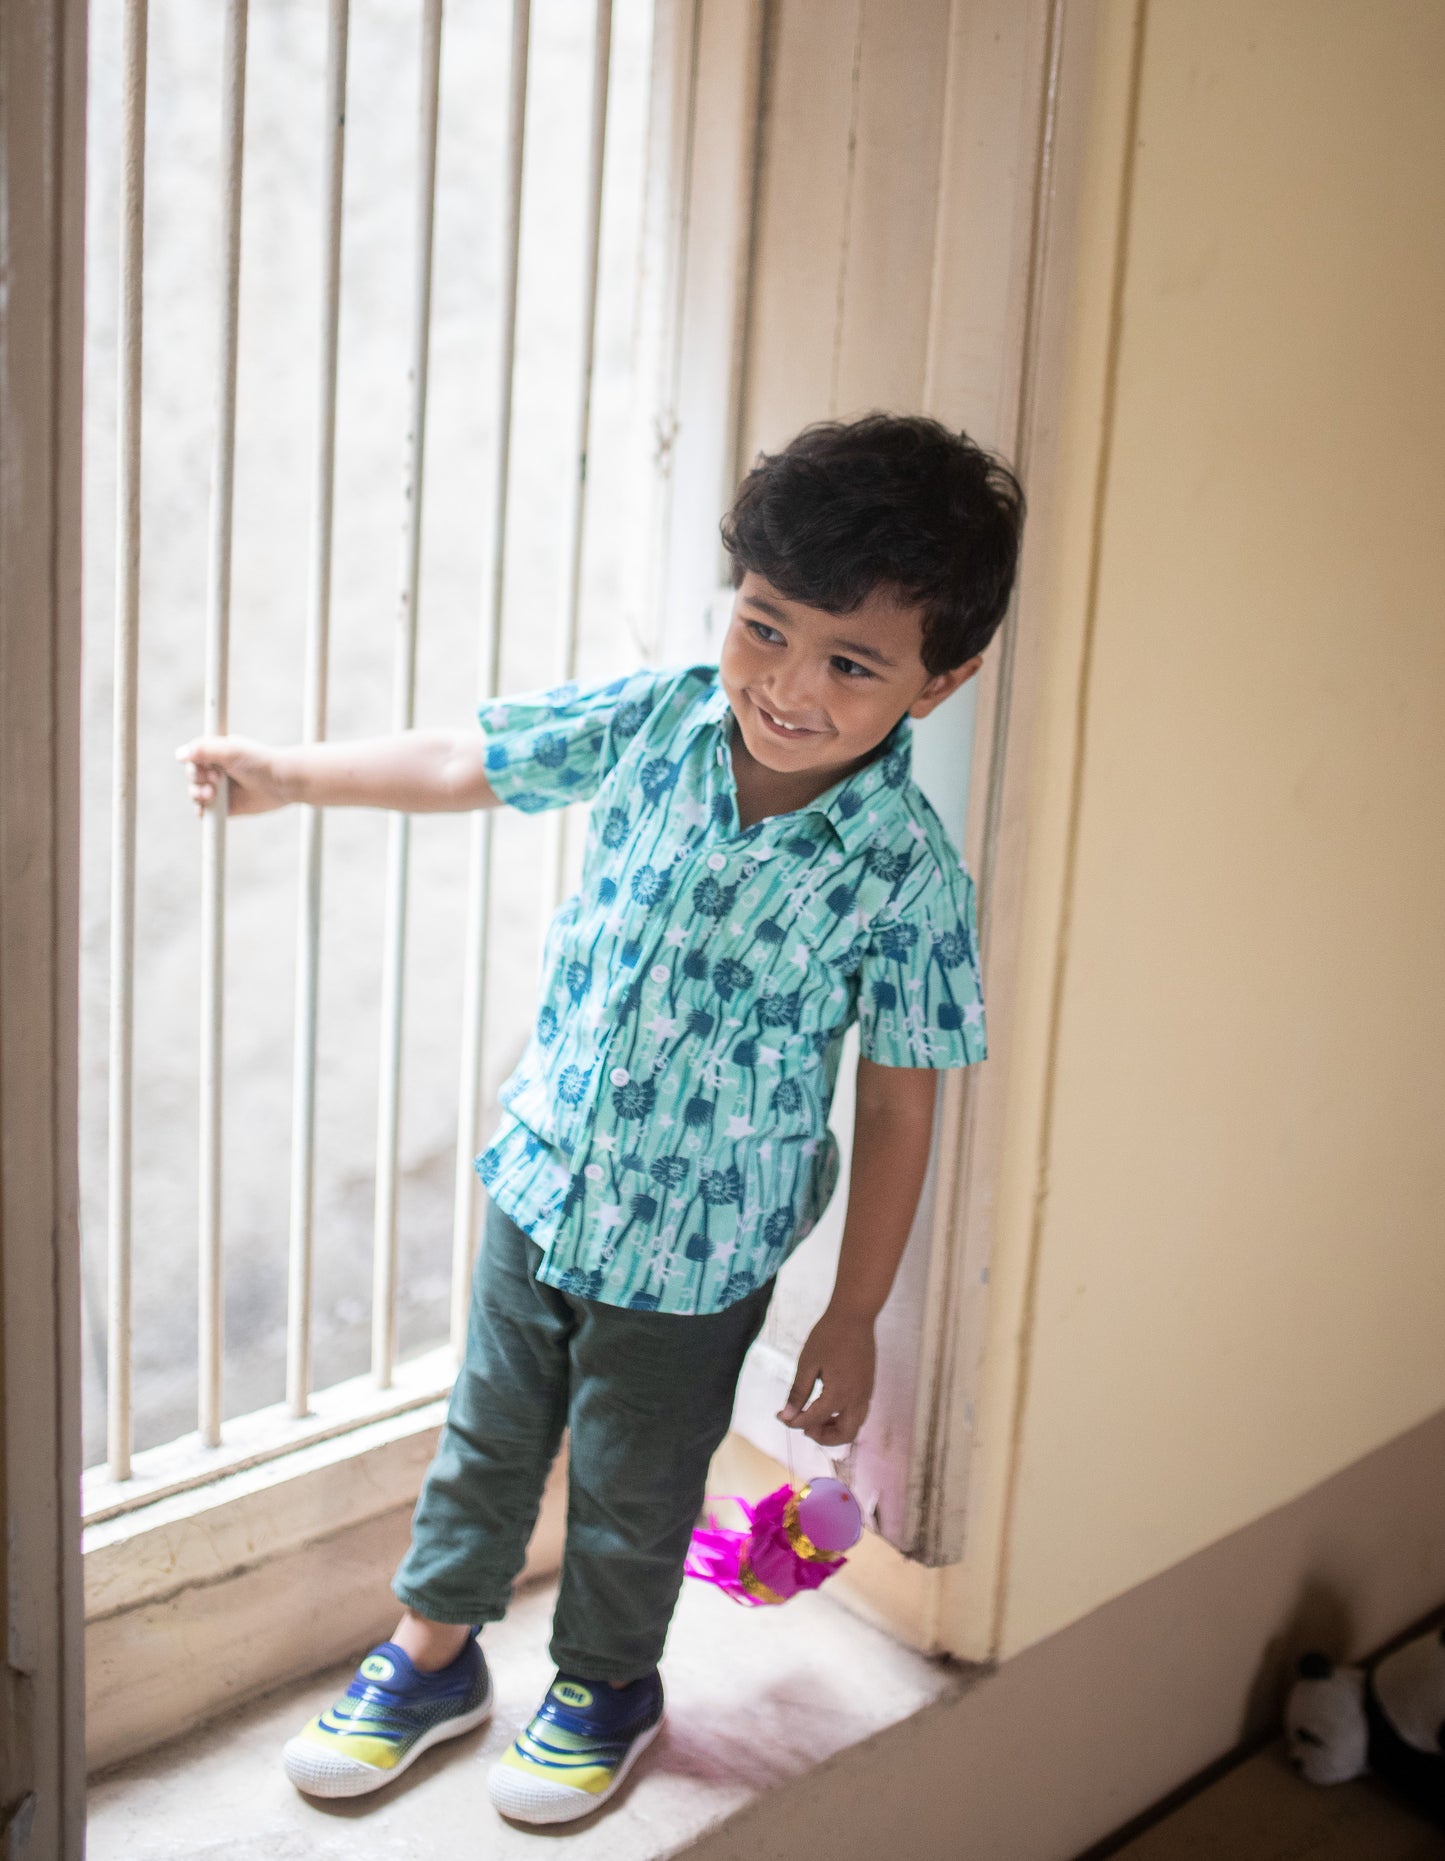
[391,1204,577,1623]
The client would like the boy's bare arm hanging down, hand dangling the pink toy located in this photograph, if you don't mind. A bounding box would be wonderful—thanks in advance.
[778,1059,939,1448]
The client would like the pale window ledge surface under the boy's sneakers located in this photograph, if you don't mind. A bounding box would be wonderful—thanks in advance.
[88,1584,963,1861]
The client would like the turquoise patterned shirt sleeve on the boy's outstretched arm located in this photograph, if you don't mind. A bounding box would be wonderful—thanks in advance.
[477,668,676,813]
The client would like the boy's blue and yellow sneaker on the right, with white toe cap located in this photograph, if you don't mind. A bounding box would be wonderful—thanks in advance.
[488,1667,663,1822]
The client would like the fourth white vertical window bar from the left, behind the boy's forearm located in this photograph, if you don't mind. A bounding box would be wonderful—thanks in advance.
[371,0,441,1388]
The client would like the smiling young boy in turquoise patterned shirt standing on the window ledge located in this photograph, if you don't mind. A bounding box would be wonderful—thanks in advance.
[177,415,1022,1822]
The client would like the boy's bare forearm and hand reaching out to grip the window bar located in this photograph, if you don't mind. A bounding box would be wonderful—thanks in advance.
[175,730,499,815]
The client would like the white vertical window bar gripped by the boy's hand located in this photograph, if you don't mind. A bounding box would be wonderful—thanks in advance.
[199,0,246,1448]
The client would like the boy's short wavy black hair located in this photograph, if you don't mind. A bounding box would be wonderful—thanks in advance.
[723,413,1024,674]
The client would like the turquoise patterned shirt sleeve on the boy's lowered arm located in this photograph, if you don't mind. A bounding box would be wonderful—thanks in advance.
[858,858,987,1068]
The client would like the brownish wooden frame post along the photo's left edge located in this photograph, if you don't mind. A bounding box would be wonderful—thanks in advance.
[0,0,86,1861]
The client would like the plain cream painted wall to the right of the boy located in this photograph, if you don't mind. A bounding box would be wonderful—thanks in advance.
[950,0,1445,1654]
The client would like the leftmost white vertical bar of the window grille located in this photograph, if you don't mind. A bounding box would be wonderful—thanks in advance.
[106,0,147,1479]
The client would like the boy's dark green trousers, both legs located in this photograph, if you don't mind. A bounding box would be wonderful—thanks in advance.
[391,1204,773,1682]
